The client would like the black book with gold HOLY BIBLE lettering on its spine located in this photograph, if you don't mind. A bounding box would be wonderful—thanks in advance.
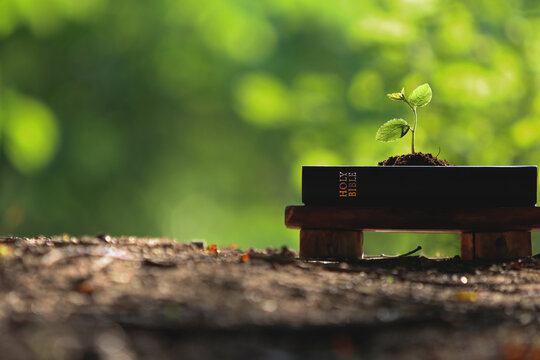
[302,166,537,207]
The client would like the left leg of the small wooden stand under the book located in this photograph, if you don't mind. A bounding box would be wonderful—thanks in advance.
[300,229,364,259]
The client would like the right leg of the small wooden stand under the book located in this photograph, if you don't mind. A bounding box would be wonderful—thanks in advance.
[461,231,532,260]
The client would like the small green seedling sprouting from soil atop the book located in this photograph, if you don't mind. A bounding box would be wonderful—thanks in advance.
[375,84,432,154]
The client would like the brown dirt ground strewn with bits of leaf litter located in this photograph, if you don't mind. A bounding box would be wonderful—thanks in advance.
[0,235,540,359]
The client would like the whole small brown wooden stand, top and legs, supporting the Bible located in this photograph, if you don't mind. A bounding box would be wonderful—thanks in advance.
[285,206,540,260]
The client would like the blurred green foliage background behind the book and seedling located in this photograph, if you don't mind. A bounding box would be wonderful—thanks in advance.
[0,0,540,255]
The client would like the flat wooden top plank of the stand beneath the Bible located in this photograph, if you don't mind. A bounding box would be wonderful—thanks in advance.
[285,206,540,233]
